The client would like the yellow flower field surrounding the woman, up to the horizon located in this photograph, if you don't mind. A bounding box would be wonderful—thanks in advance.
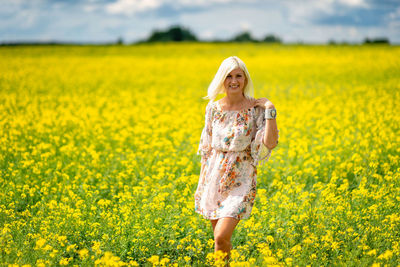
[0,43,400,266]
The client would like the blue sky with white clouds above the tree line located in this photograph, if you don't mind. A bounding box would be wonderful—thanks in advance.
[0,0,400,44]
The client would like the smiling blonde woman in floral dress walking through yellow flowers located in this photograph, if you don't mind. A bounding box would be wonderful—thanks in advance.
[195,56,279,260]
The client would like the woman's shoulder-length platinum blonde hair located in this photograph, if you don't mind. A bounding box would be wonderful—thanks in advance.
[203,56,254,102]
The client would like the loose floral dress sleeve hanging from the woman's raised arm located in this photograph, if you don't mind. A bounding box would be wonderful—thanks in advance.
[251,108,279,166]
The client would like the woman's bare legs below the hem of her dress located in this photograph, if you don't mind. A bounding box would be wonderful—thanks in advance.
[211,217,239,260]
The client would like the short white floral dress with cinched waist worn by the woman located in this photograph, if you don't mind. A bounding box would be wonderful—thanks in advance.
[194,101,271,220]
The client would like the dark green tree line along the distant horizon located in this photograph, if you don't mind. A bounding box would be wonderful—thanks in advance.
[0,25,390,45]
